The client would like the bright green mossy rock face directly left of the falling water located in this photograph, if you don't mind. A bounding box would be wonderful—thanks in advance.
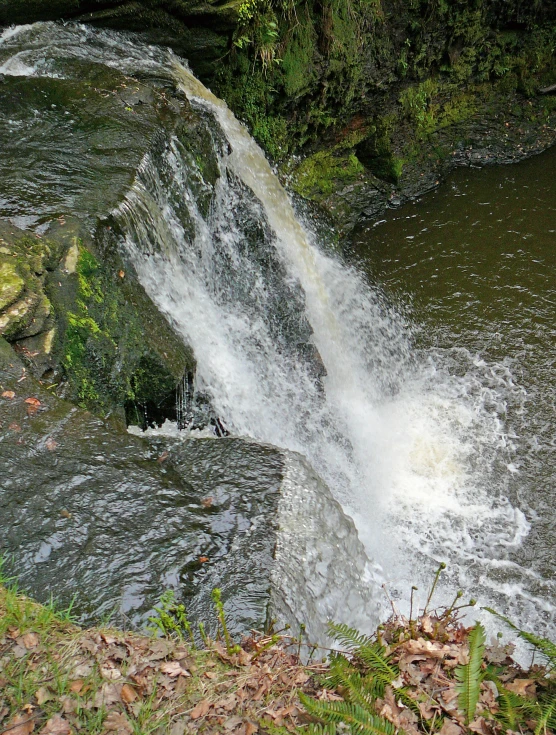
[49,240,186,423]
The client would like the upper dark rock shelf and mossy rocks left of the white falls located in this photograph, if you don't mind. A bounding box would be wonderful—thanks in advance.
[0,24,201,424]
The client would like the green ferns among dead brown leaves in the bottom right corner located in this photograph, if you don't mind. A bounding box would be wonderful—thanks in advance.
[300,565,556,735]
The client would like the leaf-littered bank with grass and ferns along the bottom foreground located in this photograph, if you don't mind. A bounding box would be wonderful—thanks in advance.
[0,587,556,735]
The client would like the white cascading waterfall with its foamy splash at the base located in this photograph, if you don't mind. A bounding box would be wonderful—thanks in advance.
[0,20,554,640]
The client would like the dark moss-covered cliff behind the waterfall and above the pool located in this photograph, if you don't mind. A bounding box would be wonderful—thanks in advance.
[0,0,556,230]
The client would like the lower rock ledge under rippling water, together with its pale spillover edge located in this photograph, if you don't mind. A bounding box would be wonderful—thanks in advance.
[0,338,376,640]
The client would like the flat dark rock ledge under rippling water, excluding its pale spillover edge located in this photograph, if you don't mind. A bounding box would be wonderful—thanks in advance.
[0,340,282,632]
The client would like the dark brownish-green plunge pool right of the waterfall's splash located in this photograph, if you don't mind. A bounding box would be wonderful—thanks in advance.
[348,149,556,630]
